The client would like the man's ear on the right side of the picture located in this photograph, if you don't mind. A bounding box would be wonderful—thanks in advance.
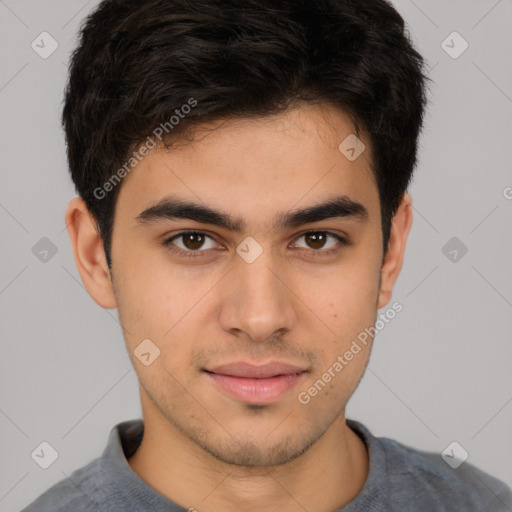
[377,192,412,309]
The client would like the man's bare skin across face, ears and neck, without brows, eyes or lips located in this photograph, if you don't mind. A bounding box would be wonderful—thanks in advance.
[66,104,412,512]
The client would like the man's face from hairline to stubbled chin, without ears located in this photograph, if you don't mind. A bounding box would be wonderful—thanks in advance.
[72,102,406,466]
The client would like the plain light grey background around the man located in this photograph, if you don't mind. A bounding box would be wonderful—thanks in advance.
[0,0,512,511]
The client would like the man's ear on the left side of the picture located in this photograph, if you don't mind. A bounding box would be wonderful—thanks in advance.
[66,197,117,308]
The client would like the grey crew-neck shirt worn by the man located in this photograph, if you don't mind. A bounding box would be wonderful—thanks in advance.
[22,420,512,512]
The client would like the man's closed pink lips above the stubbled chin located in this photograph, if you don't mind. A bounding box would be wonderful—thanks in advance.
[204,362,308,405]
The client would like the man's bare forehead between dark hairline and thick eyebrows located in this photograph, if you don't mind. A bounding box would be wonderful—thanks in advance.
[116,105,379,223]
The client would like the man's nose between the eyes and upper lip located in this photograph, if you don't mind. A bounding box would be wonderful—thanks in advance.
[219,250,300,342]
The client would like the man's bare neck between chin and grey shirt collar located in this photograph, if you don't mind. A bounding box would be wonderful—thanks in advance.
[128,394,369,512]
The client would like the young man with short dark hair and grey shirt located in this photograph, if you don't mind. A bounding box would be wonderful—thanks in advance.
[25,0,512,512]
